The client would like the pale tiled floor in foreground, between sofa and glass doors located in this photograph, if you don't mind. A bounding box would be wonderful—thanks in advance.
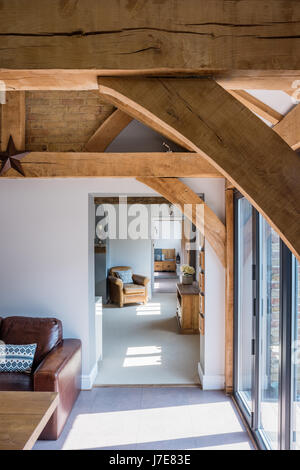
[34,387,253,450]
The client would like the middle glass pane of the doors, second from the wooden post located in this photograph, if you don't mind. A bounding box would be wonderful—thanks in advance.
[259,217,280,449]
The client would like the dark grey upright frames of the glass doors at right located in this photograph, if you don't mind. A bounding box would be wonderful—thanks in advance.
[234,191,294,450]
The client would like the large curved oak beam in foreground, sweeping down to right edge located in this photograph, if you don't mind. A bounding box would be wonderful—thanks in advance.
[99,78,300,259]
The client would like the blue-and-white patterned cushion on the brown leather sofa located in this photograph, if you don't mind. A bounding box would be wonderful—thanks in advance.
[0,342,37,373]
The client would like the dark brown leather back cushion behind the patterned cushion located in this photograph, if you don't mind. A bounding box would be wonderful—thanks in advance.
[0,317,62,370]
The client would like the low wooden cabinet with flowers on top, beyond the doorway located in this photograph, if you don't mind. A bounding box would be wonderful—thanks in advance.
[176,284,200,334]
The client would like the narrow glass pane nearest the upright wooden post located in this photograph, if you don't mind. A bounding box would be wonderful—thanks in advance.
[237,198,253,412]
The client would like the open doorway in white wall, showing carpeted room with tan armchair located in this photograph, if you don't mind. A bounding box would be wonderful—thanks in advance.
[95,196,200,386]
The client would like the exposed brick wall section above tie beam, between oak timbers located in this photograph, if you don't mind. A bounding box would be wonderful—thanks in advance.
[26,91,113,152]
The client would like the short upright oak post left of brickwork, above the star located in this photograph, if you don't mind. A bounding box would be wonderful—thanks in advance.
[0,91,25,151]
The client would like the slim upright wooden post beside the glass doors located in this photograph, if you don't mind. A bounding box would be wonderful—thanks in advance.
[225,185,234,394]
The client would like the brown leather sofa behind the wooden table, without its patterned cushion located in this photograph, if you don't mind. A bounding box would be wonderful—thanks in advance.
[0,317,81,440]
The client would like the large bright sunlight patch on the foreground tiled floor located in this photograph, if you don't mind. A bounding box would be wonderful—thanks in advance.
[63,402,248,449]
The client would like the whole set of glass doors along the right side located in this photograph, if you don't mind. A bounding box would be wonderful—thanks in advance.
[234,193,300,450]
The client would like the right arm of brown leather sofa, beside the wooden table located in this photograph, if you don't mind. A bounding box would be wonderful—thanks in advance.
[33,339,81,440]
